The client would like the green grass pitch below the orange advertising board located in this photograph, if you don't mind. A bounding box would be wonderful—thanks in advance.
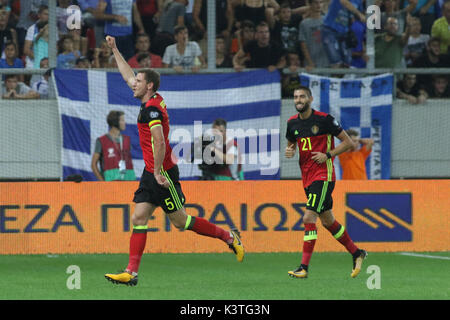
[0,252,450,300]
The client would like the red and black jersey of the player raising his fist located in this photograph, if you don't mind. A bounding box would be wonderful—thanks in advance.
[137,93,176,173]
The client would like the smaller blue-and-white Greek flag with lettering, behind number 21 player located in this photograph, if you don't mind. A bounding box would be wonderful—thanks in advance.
[300,73,394,179]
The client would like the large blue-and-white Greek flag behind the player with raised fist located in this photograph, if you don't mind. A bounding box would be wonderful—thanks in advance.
[54,69,281,181]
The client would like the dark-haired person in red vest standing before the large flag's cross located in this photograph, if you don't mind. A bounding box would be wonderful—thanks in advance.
[91,110,136,181]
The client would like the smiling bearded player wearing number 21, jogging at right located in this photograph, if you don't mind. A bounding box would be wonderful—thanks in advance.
[285,86,367,278]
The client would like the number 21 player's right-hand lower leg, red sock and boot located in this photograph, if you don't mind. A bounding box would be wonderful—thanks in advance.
[320,209,367,278]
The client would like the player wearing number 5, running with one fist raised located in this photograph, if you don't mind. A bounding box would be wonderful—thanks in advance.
[105,36,245,285]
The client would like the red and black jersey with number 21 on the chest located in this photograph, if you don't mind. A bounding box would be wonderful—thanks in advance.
[286,109,342,188]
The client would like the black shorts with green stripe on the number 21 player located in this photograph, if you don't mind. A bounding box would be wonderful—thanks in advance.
[305,180,335,214]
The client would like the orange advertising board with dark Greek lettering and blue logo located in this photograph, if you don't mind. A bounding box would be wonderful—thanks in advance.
[0,180,450,254]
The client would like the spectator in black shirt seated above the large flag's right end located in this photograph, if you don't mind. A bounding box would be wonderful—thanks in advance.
[233,21,286,71]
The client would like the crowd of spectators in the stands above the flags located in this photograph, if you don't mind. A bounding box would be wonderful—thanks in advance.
[0,0,450,100]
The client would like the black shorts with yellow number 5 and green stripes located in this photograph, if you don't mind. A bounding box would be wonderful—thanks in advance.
[133,165,186,213]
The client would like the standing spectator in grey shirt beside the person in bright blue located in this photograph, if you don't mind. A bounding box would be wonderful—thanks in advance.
[299,0,329,71]
